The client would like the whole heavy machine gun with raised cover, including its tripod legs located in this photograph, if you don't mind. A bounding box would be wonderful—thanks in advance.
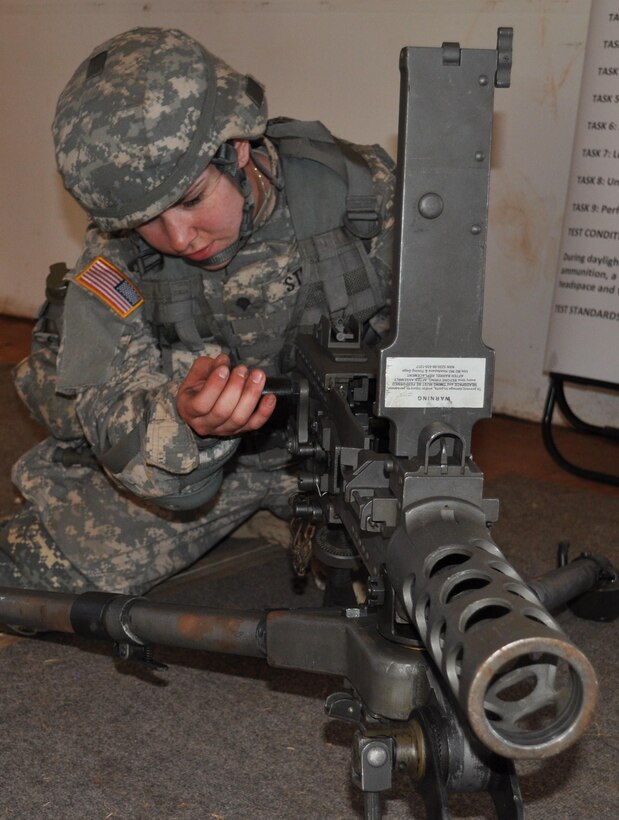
[0,29,612,820]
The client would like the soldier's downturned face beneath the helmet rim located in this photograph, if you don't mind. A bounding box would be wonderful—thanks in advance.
[136,143,249,270]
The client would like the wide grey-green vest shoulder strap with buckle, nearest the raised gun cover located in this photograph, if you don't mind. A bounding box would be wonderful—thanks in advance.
[267,119,384,370]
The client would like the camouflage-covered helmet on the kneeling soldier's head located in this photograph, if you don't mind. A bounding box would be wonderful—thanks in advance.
[52,28,267,231]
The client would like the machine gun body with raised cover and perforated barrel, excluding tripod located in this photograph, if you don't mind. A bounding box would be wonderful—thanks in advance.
[288,30,597,758]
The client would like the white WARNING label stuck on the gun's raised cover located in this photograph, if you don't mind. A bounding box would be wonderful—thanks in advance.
[385,356,486,408]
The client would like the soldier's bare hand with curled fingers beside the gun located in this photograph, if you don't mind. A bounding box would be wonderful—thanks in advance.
[176,353,277,436]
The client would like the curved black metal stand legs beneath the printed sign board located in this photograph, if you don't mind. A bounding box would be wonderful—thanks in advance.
[542,373,619,487]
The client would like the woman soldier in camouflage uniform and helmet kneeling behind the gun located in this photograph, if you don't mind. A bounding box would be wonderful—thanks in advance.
[0,28,393,594]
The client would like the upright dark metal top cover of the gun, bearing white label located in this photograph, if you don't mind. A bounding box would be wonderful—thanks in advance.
[376,44,497,457]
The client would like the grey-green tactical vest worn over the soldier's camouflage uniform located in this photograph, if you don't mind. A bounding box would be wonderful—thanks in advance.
[134,119,386,372]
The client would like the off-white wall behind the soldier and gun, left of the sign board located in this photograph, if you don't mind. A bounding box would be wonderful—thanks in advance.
[0,0,605,418]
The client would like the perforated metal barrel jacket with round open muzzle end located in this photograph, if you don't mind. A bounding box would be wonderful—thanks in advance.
[387,498,597,759]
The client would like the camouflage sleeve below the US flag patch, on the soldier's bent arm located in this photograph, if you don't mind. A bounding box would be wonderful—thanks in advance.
[57,231,238,509]
